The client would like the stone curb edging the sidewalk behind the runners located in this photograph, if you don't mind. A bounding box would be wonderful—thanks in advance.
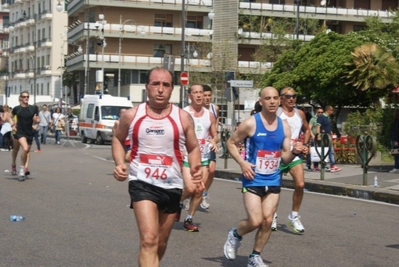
[215,170,399,205]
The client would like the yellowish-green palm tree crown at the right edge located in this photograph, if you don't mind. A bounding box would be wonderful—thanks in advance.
[345,43,399,104]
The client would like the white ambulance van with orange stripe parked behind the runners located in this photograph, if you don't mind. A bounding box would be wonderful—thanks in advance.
[79,95,133,145]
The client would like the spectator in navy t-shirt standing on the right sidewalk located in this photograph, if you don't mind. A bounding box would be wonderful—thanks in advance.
[316,106,342,172]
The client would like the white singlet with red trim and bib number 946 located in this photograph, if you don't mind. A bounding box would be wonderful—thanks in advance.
[129,103,186,189]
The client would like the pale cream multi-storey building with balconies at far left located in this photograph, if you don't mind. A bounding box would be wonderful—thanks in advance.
[2,0,69,105]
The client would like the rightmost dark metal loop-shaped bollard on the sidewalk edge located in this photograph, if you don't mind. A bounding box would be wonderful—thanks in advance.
[356,132,377,185]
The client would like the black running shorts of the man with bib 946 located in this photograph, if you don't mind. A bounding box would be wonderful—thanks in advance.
[129,180,183,213]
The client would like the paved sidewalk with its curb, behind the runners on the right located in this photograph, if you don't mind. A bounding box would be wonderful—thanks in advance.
[215,153,399,205]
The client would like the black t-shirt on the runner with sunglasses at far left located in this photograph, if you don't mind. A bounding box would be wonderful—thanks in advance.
[12,105,39,136]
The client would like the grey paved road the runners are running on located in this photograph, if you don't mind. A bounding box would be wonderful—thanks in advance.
[0,143,399,267]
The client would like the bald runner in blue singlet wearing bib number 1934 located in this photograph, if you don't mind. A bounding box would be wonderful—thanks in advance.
[224,87,304,266]
